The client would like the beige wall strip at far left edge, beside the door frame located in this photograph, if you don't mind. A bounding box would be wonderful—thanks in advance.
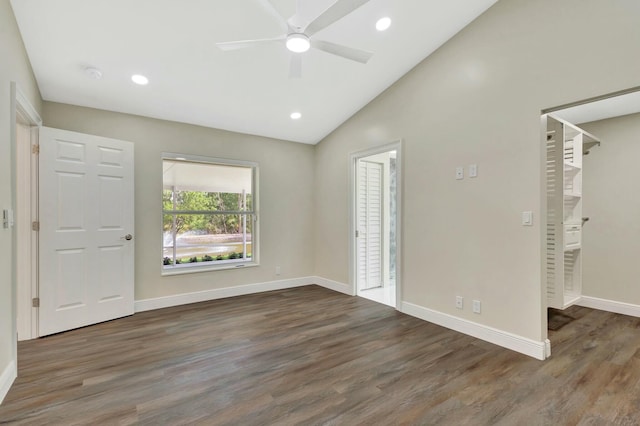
[0,0,41,390]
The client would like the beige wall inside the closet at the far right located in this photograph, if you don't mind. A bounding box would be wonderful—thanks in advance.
[579,114,640,305]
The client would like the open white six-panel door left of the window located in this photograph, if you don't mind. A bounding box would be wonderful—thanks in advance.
[39,127,134,336]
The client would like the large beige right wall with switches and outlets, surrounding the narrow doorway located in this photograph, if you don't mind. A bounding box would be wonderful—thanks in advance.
[315,0,640,341]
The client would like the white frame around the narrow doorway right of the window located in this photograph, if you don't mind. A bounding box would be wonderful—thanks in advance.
[349,140,404,310]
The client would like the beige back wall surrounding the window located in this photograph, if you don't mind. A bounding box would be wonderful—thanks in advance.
[43,102,314,300]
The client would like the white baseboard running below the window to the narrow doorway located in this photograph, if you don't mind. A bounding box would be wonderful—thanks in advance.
[135,277,352,312]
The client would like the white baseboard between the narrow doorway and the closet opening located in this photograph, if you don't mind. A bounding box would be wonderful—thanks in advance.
[402,302,550,360]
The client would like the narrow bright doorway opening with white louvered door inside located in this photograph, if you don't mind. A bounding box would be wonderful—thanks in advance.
[351,143,401,308]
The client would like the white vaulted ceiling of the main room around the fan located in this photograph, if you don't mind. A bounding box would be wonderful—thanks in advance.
[11,0,497,144]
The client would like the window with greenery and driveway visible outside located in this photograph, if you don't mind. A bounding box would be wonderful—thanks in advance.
[162,153,258,273]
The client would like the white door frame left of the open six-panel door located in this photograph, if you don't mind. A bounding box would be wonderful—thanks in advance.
[10,82,42,340]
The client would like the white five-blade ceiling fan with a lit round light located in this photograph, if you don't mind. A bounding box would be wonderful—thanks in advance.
[216,0,373,78]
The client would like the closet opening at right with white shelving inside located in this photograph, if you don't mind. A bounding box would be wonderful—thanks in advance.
[542,87,640,350]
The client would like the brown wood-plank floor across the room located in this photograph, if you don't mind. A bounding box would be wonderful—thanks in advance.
[0,286,640,425]
